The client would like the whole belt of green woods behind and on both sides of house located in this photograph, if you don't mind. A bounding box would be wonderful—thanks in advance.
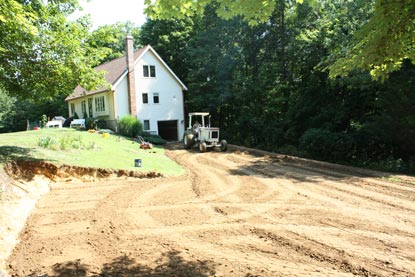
[0,0,415,173]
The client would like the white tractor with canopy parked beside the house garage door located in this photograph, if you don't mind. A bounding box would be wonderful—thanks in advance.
[183,112,228,152]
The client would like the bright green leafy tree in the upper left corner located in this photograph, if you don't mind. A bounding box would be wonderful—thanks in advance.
[0,0,105,99]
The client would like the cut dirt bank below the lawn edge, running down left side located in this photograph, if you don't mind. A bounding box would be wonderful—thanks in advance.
[0,160,162,277]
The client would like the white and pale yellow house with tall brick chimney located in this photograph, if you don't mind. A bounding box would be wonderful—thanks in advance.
[65,36,187,140]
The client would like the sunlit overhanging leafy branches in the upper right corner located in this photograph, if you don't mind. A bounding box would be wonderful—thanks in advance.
[329,0,415,80]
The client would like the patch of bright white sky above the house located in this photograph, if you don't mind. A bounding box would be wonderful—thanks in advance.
[69,0,146,29]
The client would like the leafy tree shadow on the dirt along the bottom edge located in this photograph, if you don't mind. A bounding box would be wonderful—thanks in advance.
[34,251,219,277]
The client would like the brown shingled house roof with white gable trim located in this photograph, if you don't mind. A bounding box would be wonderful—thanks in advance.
[65,45,187,101]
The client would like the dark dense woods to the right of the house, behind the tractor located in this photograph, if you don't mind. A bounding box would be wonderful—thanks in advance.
[140,0,415,172]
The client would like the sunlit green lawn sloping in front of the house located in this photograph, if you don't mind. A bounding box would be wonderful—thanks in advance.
[0,128,185,176]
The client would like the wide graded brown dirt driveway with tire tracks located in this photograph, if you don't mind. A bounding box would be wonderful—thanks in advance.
[7,143,415,277]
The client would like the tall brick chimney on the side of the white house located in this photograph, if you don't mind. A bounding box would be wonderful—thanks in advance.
[125,36,137,116]
